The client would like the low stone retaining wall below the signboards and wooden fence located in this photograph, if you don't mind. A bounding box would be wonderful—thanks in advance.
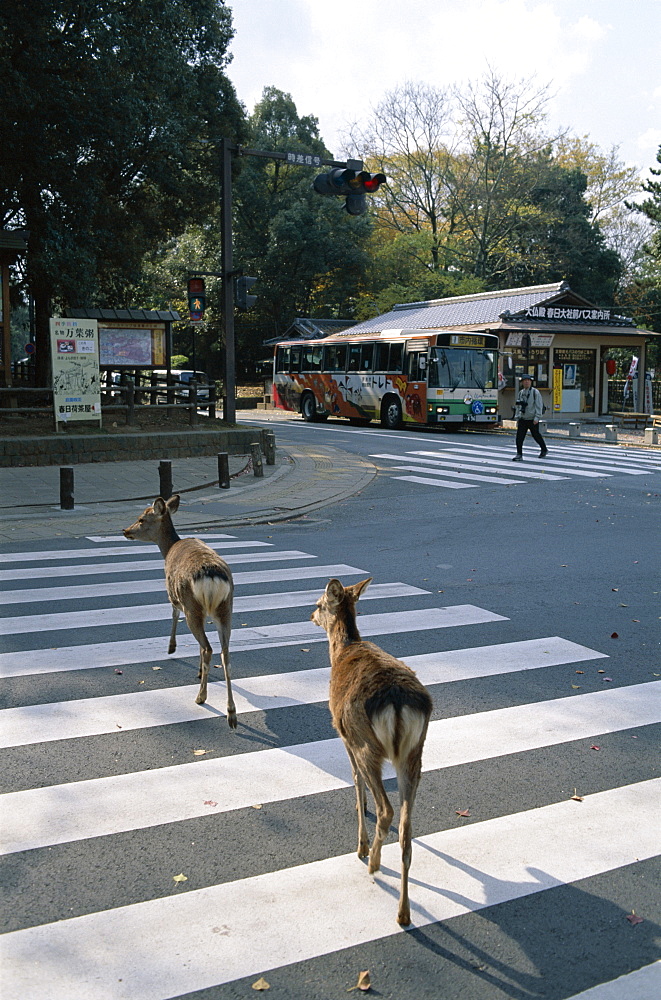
[0,426,266,468]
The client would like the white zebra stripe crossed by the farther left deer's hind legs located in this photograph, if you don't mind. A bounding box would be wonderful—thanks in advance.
[0,636,608,747]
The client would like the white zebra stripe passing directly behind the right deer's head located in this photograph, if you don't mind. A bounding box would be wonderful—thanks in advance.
[0,583,429,635]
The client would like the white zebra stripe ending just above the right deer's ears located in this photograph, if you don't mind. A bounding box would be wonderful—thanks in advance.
[2,563,369,605]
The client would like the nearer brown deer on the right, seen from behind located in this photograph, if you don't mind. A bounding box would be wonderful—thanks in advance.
[310,577,433,927]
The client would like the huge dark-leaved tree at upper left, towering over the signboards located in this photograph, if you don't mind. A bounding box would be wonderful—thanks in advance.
[0,0,242,384]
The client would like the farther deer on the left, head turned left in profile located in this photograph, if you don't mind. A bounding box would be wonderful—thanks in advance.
[124,493,236,729]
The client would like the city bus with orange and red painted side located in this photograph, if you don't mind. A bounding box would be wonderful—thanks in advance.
[273,330,499,430]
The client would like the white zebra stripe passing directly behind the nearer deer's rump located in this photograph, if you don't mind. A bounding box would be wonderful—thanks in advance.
[0,681,661,854]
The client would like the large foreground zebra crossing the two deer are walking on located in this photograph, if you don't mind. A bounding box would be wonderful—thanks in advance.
[0,536,661,1000]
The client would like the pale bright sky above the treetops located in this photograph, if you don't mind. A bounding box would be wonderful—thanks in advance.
[226,0,661,176]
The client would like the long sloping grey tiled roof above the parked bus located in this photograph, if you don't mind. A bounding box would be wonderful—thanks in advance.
[351,281,578,333]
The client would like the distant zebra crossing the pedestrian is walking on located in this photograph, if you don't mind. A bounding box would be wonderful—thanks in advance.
[370,442,661,490]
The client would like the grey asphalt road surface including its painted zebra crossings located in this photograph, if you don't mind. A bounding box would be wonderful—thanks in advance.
[0,421,661,1000]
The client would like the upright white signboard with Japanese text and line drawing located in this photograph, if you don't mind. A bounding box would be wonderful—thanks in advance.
[50,319,101,428]
